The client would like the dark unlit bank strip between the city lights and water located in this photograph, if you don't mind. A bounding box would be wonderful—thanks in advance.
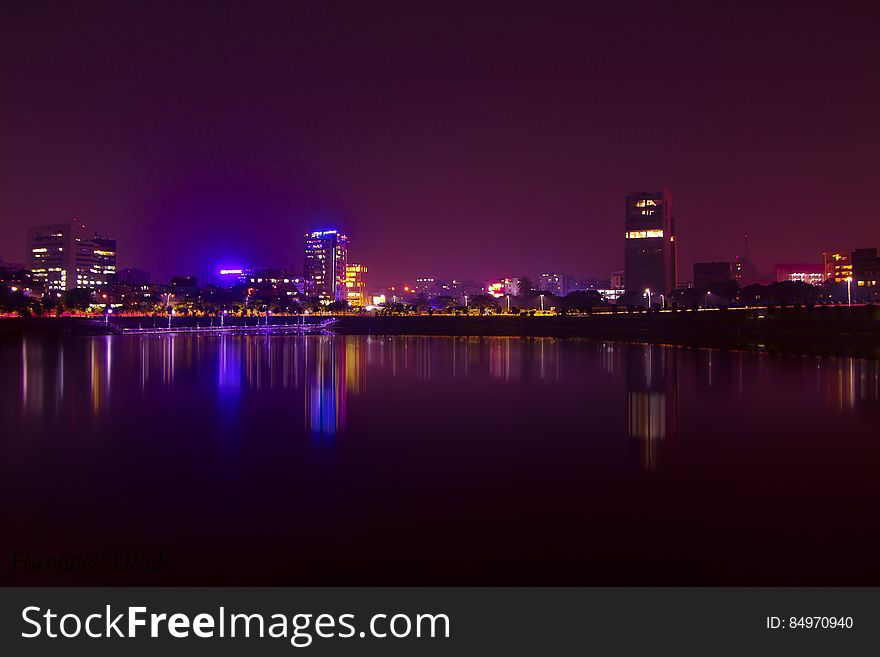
[0,306,880,359]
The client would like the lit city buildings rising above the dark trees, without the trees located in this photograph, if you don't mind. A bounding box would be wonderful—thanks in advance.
[12,209,880,296]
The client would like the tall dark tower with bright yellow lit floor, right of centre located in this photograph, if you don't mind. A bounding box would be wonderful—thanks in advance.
[624,188,678,294]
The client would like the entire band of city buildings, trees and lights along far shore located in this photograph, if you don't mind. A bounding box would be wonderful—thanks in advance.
[0,188,880,313]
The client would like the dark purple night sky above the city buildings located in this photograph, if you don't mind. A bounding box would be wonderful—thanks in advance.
[0,1,880,287]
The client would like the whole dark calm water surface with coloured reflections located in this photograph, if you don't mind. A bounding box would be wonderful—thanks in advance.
[0,335,880,585]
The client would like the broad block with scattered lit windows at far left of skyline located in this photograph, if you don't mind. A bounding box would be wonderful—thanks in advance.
[27,219,116,292]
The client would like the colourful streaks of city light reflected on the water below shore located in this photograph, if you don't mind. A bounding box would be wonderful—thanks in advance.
[4,335,880,446]
